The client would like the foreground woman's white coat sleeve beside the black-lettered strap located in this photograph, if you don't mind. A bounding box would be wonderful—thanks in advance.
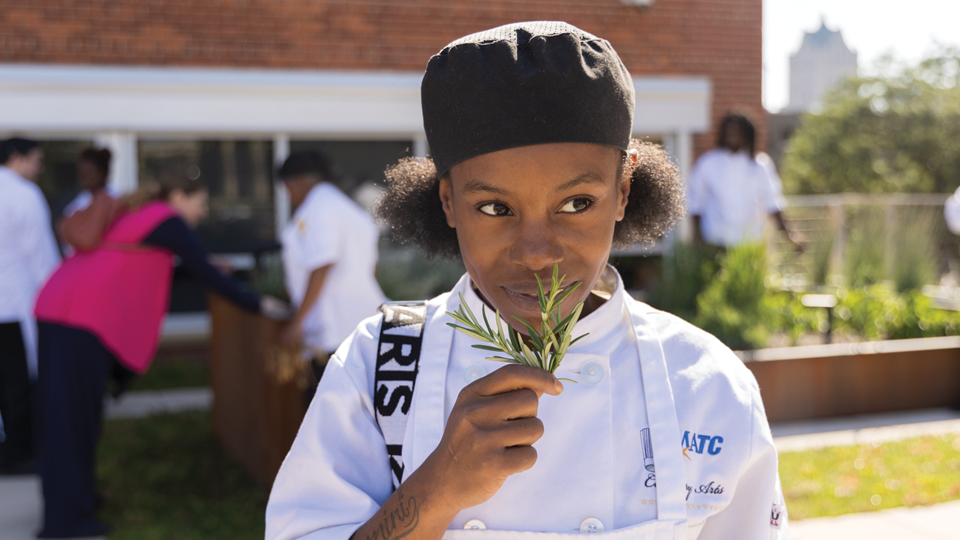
[266,316,393,540]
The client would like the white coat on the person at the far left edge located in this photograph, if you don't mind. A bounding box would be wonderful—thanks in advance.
[0,165,60,378]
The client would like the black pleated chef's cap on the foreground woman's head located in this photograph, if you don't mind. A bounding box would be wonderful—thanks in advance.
[420,21,634,176]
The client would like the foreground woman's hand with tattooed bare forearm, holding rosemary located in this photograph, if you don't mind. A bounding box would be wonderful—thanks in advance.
[352,365,563,540]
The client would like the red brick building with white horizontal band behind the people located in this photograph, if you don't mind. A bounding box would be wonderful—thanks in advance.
[0,0,764,268]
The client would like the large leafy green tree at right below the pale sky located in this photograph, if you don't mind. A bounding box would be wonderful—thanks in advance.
[781,46,960,194]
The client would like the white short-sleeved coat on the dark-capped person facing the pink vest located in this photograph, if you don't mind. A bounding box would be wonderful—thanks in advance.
[283,182,386,352]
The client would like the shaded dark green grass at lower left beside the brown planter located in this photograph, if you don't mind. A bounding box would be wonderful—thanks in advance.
[97,412,268,540]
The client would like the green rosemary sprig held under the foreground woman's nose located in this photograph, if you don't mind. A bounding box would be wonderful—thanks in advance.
[447,264,587,382]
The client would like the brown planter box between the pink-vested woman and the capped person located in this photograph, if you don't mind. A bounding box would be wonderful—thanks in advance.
[207,294,305,488]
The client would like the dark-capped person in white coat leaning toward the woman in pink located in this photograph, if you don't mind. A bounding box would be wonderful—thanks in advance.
[278,150,386,399]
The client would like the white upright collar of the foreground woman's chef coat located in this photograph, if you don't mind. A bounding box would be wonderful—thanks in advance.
[453,264,627,353]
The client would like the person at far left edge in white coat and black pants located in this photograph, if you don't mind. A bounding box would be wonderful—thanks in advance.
[0,138,60,474]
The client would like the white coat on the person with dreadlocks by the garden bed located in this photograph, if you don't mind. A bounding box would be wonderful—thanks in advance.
[687,148,784,247]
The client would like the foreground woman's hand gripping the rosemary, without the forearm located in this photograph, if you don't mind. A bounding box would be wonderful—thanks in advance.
[422,365,563,511]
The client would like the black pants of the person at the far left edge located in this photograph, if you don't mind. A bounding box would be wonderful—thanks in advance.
[0,322,34,472]
